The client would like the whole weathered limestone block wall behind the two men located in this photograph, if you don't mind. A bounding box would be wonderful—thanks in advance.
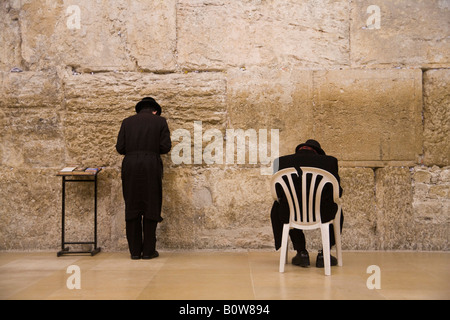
[0,0,450,251]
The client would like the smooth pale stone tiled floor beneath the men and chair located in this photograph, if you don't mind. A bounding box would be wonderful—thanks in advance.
[0,251,450,300]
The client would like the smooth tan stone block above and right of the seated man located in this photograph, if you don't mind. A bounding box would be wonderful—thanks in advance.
[313,69,422,166]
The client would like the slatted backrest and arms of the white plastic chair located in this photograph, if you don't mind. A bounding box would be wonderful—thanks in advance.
[271,167,340,228]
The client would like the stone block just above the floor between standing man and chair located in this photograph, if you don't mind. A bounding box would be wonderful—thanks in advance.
[158,166,273,249]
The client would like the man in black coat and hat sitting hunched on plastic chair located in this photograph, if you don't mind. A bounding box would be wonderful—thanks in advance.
[271,140,344,267]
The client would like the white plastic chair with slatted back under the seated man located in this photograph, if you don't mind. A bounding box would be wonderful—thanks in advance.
[271,167,342,276]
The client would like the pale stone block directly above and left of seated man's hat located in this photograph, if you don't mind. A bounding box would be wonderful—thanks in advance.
[227,67,313,155]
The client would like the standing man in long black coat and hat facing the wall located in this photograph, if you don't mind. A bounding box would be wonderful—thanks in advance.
[116,98,172,259]
